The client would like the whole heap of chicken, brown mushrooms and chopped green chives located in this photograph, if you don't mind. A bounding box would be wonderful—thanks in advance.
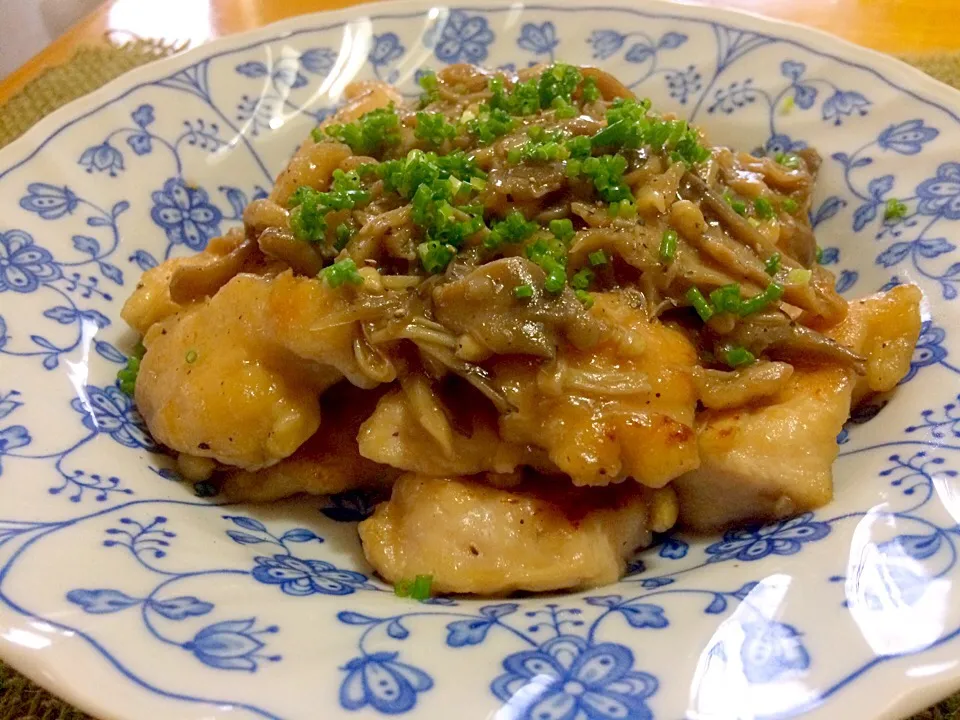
[120,63,921,597]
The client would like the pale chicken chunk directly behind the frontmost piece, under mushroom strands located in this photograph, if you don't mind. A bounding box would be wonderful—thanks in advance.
[358,378,542,475]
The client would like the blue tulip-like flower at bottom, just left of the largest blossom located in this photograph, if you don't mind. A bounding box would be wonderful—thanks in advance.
[340,652,433,715]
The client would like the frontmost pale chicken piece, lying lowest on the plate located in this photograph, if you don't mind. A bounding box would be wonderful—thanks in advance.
[359,474,677,595]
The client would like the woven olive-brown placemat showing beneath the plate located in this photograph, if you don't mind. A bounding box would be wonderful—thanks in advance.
[0,40,960,720]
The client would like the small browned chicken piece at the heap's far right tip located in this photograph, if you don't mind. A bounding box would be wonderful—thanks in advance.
[824,285,923,406]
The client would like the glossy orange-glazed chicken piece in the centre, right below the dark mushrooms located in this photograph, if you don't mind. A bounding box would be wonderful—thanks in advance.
[491,293,699,487]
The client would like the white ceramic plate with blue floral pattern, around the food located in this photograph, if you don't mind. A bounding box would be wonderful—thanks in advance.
[0,0,960,720]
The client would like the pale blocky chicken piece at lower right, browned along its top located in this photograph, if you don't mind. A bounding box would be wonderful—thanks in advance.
[673,368,854,531]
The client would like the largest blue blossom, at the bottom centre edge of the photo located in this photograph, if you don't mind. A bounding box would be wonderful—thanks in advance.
[490,635,657,720]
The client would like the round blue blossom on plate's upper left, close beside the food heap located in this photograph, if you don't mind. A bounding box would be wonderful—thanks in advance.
[150,178,223,250]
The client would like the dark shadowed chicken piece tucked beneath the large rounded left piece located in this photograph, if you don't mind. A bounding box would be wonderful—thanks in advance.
[221,383,400,502]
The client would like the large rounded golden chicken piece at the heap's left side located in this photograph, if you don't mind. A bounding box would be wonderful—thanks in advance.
[136,275,332,469]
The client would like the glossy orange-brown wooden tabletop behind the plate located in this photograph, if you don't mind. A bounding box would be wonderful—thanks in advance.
[0,0,960,102]
